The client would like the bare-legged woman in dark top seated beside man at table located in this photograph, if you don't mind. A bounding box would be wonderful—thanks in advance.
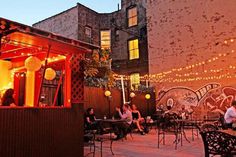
[131,104,145,135]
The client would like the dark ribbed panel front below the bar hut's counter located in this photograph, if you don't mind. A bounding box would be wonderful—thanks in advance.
[0,105,83,157]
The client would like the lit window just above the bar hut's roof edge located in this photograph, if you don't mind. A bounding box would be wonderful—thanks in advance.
[100,30,111,49]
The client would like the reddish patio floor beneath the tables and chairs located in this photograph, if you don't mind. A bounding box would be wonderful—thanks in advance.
[85,129,204,157]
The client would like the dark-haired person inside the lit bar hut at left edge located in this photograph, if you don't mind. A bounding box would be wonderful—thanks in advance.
[2,88,16,107]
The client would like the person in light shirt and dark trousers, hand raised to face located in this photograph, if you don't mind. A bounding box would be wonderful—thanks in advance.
[115,104,133,139]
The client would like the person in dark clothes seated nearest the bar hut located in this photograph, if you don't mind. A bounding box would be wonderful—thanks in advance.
[85,107,97,130]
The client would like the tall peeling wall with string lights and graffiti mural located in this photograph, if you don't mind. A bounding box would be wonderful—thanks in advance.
[147,0,236,113]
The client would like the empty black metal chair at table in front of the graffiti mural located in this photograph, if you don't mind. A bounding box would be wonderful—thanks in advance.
[157,113,183,149]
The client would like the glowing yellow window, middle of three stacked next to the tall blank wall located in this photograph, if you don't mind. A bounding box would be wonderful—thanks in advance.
[129,39,139,60]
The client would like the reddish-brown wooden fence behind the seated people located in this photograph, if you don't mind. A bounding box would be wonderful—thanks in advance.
[84,87,155,118]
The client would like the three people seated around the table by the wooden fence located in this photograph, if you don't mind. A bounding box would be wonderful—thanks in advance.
[85,104,145,139]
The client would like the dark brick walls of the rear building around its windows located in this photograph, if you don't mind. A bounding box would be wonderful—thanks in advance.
[33,0,148,74]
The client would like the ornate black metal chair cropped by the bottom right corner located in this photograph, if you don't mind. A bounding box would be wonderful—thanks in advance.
[200,131,236,157]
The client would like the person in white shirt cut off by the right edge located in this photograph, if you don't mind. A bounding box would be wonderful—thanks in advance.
[224,101,236,128]
